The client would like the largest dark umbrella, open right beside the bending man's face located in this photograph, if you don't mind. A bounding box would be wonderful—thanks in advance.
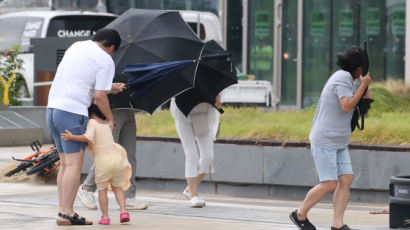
[105,9,204,109]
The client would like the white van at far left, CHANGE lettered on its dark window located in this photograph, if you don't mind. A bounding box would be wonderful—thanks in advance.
[0,11,116,105]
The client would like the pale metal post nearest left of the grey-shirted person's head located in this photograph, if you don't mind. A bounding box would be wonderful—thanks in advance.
[296,0,303,109]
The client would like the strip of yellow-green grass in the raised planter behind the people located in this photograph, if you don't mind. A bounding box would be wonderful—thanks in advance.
[136,81,410,145]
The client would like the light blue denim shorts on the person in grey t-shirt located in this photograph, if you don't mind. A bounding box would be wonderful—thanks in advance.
[310,145,353,182]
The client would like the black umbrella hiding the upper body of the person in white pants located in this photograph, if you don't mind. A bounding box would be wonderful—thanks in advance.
[175,40,238,116]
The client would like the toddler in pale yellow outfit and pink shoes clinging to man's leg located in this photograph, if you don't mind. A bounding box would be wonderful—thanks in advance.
[61,104,132,225]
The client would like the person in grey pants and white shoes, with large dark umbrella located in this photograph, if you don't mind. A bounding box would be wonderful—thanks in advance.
[78,8,203,210]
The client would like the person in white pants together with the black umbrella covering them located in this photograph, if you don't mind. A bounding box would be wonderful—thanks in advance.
[171,40,238,207]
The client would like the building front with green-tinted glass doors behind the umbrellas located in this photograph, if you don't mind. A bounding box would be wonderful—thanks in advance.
[106,0,410,109]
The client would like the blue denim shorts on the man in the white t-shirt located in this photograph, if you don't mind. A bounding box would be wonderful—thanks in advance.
[46,108,88,154]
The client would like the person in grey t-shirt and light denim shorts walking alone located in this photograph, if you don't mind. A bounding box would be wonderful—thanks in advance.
[290,47,371,230]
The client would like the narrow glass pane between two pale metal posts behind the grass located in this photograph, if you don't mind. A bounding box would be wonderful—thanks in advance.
[280,0,298,105]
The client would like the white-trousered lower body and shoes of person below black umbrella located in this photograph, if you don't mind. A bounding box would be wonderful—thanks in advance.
[171,96,221,207]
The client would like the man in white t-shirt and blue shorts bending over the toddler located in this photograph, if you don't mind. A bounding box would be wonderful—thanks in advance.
[47,29,125,225]
